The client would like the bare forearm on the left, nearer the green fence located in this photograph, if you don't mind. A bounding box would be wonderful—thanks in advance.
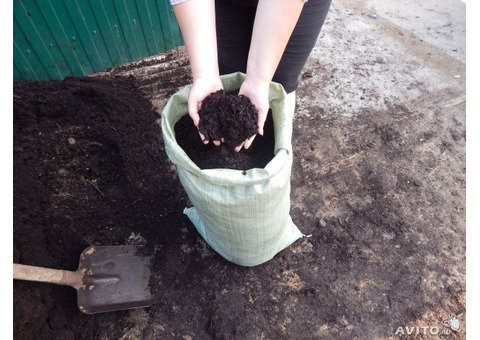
[173,0,219,80]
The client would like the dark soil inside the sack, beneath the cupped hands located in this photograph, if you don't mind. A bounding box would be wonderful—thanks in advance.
[175,112,275,170]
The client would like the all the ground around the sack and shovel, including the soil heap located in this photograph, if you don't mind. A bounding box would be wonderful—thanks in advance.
[13,0,466,339]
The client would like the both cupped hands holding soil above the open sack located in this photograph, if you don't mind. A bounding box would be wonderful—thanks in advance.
[188,75,269,152]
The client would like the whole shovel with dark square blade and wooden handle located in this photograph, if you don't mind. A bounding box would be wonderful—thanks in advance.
[13,245,153,314]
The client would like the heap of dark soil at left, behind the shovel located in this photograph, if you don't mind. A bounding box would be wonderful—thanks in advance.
[13,77,188,339]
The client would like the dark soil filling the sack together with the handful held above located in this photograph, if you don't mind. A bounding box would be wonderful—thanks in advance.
[175,91,275,170]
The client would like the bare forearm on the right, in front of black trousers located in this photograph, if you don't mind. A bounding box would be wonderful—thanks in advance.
[247,0,304,83]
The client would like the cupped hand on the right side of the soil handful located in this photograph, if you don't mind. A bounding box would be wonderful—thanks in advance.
[235,75,270,152]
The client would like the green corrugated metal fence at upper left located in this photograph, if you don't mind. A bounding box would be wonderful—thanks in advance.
[13,0,183,80]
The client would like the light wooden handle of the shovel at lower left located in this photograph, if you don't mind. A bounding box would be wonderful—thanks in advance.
[13,263,83,289]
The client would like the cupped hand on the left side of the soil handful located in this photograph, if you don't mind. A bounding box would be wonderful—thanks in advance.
[188,76,223,145]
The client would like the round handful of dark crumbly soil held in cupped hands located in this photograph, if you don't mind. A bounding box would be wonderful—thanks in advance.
[198,90,258,148]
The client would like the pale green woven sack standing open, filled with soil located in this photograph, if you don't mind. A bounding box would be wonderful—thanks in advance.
[162,73,304,266]
